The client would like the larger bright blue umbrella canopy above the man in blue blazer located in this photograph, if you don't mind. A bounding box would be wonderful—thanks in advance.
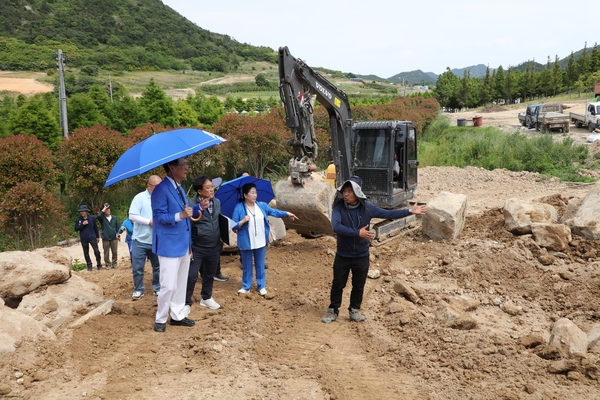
[104,128,225,187]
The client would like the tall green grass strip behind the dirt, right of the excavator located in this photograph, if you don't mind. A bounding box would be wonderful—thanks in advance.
[419,116,594,182]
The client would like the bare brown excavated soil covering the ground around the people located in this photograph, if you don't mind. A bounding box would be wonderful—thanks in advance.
[0,167,600,400]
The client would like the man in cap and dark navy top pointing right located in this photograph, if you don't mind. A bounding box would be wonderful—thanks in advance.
[321,176,427,324]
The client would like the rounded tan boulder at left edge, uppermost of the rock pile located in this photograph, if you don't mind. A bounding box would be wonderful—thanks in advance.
[0,247,71,301]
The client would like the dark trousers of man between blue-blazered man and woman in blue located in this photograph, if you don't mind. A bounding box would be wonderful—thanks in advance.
[185,243,223,306]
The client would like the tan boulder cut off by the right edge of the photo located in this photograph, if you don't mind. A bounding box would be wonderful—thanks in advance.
[561,182,600,240]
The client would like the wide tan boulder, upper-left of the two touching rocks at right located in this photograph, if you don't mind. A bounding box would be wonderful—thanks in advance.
[502,198,558,235]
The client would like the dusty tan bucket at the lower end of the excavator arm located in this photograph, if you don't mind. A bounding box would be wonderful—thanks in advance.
[275,174,336,237]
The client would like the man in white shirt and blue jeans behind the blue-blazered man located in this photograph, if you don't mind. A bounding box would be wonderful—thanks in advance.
[129,175,161,300]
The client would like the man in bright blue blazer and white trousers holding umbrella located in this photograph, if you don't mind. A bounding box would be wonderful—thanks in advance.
[151,158,196,332]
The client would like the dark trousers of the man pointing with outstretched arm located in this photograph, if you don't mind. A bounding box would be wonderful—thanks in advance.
[329,254,369,313]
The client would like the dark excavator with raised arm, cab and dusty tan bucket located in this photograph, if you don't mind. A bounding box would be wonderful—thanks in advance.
[275,47,419,242]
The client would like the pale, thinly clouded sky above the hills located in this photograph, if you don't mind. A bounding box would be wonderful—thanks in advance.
[163,0,599,78]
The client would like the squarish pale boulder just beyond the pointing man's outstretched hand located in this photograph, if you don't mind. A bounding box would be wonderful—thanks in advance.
[421,192,467,240]
